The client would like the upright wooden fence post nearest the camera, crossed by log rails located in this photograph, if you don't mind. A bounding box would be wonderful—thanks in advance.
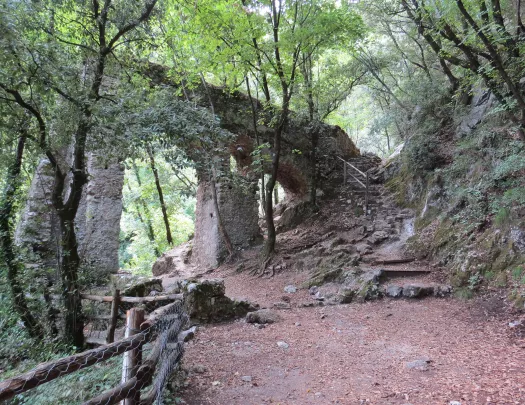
[121,308,144,405]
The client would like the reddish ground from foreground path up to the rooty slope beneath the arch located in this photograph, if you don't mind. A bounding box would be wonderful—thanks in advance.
[166,181,525,405]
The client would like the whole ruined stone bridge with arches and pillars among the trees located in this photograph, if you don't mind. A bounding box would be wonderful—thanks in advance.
[16,69,359,275]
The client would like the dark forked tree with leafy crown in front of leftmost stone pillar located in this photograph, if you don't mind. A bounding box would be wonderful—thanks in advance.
[0,0,157,347]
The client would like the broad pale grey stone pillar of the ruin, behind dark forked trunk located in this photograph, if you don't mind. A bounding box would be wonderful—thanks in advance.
[15,153,124,277]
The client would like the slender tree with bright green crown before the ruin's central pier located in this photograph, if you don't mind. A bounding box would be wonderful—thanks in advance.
[166,0,363,260]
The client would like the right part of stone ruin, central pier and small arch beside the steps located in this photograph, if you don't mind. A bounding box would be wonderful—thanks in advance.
[186,86,360,268]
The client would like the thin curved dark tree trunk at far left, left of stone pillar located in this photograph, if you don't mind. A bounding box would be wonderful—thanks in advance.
[0,134,43,339]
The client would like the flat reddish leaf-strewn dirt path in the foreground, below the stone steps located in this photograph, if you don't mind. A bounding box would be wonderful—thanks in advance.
[182,274,525,405]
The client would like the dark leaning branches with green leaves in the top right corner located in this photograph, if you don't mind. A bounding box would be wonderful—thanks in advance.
[401,0,525,142]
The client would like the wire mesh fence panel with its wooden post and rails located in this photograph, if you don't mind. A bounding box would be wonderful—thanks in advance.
[0,299,188,405]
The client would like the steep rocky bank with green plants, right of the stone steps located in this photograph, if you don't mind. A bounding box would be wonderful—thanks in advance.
[387,95,525,301]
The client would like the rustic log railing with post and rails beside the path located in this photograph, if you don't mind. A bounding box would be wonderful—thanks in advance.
[0,292,190,405]
